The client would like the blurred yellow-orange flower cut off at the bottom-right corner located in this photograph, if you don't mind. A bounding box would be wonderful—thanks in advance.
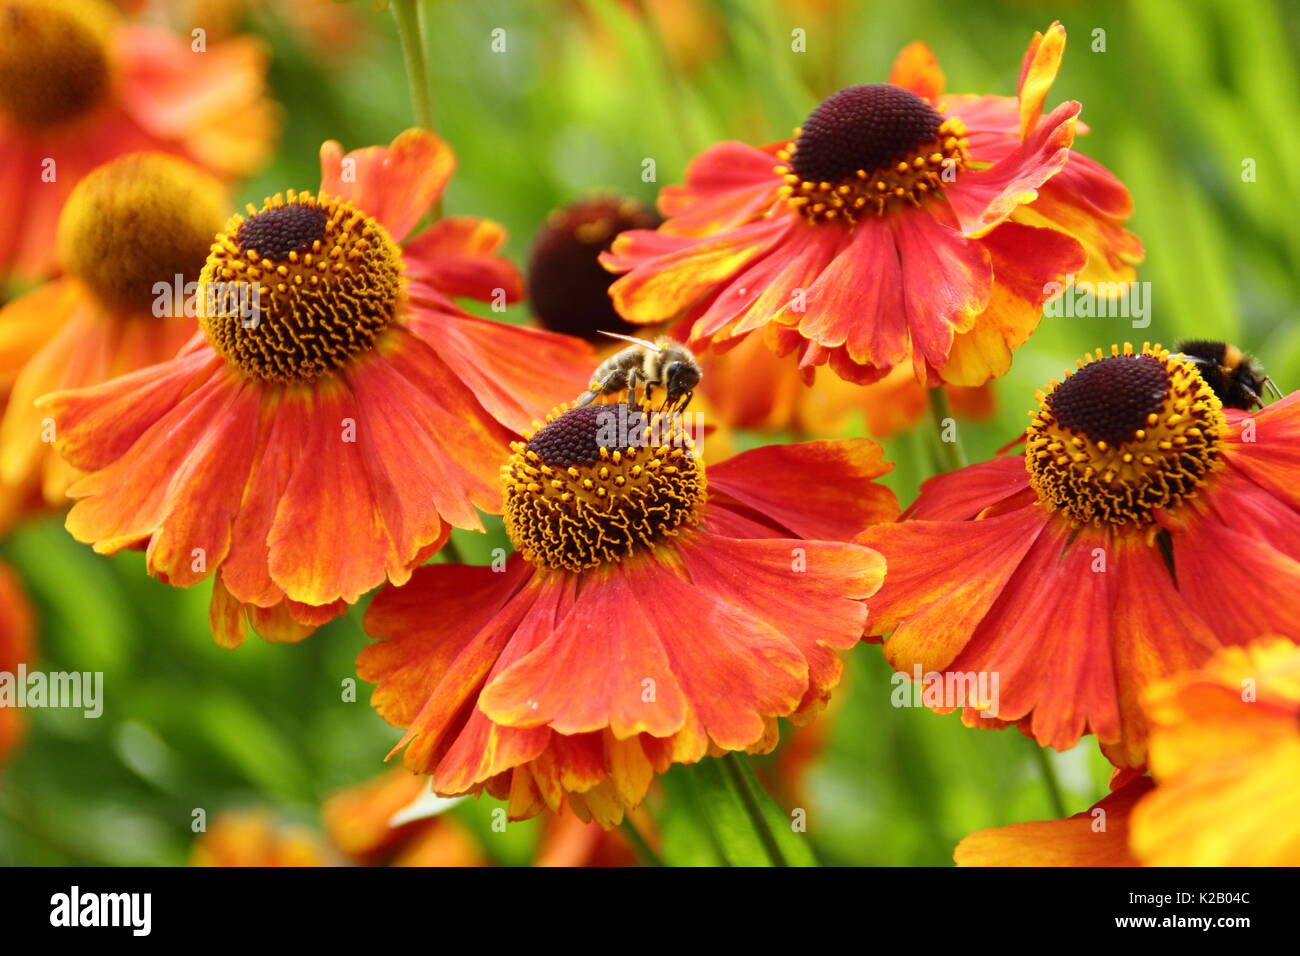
[956,637,1300,866]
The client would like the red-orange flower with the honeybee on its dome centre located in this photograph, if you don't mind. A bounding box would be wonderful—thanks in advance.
[358,405,896,826]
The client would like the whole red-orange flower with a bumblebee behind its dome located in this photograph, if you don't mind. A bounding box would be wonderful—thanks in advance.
[861,345,1300,767]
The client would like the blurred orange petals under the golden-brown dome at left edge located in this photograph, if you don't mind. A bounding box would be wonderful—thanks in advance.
[0,277,195,507]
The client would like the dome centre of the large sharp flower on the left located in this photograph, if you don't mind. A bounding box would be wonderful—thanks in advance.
[200,190,403,384]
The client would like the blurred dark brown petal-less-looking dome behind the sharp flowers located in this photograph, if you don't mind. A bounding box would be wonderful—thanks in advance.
[528,196,660,345]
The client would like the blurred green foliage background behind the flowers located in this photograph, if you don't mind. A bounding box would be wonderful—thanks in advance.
[0,0,1300,865]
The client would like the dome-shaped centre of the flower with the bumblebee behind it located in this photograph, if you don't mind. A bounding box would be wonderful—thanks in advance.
[1024,345,1227,527]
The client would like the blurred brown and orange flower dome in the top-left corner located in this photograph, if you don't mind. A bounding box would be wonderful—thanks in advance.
[0,0,114,130]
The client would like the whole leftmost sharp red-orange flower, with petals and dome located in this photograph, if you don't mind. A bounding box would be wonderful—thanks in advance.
[39,130,593,646]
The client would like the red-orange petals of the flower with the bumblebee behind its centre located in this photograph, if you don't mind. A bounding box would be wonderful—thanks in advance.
[858,395,1300,767]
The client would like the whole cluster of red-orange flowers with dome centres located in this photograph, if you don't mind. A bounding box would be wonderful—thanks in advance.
[0,0,1300,862]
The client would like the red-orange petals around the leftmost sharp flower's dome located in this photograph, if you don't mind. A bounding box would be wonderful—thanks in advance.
[40,130,592,645]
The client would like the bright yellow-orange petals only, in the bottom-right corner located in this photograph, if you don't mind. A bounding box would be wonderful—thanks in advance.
[1130,637,1300,866]
